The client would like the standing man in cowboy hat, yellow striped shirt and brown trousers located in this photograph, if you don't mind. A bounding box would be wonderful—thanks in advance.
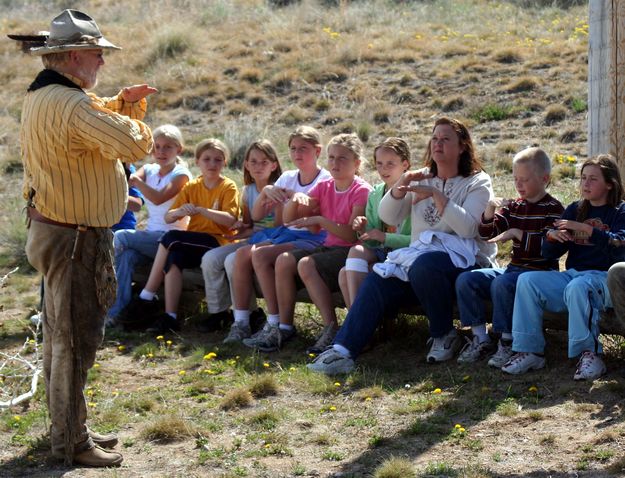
[20,10,156,466]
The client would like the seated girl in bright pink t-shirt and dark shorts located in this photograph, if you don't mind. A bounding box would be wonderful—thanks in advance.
[243,134,371,353]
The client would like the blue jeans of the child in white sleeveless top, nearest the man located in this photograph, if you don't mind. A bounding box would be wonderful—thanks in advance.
[107,229,164,317]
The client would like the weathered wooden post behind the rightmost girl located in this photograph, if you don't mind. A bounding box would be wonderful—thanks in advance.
[588,0,625,174]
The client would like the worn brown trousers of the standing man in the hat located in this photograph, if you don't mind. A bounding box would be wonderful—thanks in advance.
[26,221,105,460]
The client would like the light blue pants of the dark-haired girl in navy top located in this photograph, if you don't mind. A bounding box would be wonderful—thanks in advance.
[512,269,612,358]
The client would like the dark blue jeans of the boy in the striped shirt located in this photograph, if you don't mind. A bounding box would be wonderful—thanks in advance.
[456,266,529,333]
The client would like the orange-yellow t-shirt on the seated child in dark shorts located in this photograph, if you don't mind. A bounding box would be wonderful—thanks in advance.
[170,176,239,245]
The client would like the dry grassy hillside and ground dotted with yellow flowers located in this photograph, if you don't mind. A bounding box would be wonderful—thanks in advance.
[0,0,625,478]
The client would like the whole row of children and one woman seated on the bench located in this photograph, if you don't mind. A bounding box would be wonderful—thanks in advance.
[109,118,625,380]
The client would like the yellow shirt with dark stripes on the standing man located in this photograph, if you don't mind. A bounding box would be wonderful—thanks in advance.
[20,74,152,227]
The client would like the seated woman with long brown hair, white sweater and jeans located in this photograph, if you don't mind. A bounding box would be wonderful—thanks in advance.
[308,117,497,374]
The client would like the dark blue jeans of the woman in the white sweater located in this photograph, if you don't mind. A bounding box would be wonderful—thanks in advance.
[334,252,469,358]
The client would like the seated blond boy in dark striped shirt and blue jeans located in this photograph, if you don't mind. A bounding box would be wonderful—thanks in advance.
[456,148,564,368]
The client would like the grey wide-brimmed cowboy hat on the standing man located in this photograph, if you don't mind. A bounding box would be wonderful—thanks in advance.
[30,10,121,55]
